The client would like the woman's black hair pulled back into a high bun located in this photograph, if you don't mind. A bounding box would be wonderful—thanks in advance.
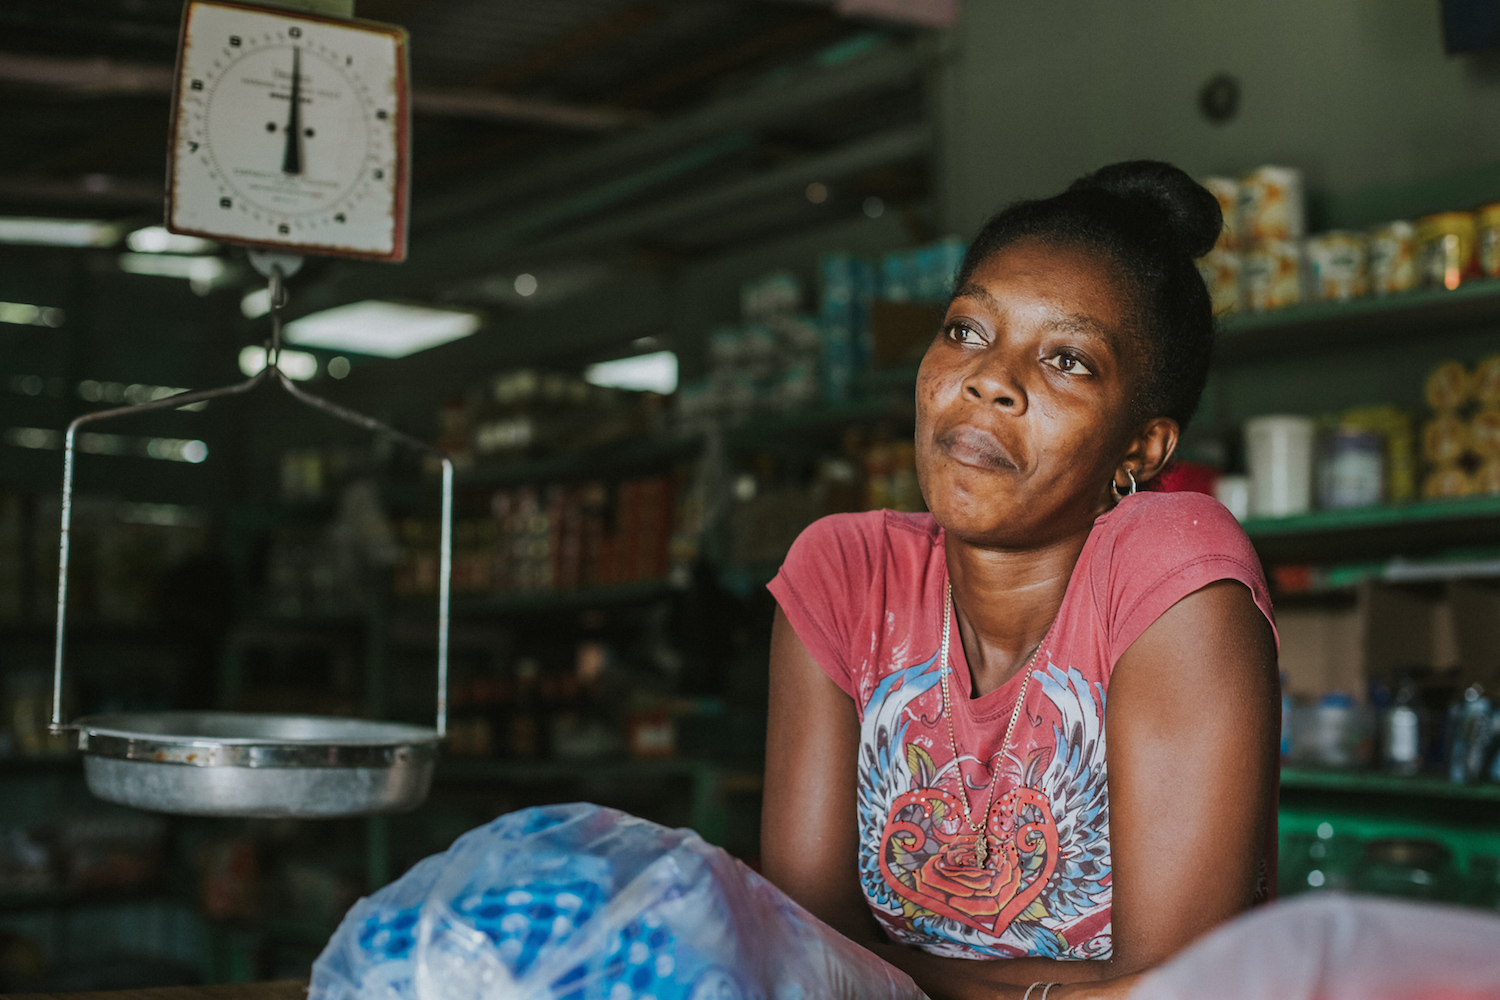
[956,160,1224,427]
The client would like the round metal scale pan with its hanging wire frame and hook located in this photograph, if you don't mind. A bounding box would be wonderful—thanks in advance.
[51,260,453,819]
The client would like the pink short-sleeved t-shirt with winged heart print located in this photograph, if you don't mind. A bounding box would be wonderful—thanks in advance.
[771,493,1274,958]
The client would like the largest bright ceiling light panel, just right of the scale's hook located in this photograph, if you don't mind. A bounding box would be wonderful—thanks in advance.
[285,300,480,358]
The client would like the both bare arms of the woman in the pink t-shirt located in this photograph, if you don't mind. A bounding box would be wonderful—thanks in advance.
[761,580,1280,1000]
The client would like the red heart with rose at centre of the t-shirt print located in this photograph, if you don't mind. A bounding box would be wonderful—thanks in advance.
[881,786,1058,937]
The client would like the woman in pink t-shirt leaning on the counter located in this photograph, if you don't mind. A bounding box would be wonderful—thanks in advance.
[762,162,1280,1000]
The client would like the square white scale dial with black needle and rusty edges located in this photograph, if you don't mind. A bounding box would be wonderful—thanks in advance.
[167,0,410,261]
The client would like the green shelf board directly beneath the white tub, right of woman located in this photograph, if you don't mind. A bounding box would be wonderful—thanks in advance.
[1244,496,1500,564]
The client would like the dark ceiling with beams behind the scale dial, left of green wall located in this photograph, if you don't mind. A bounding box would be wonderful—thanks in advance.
[0,0,930,312]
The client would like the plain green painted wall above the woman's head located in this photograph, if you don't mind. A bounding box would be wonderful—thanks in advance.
[941,0,1500,232]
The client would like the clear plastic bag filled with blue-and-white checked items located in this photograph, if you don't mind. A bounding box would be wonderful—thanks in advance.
[309,804,923,1000]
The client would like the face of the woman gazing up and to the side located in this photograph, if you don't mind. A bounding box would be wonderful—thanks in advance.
[917,240,1140,547]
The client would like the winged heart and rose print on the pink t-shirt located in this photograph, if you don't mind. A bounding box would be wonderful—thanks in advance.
[860,657,1113,960]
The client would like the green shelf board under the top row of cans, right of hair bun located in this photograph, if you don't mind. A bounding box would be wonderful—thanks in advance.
[1215,280,1500,364]
